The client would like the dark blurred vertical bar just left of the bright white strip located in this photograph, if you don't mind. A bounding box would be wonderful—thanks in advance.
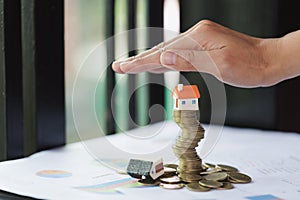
[147,0,164,122]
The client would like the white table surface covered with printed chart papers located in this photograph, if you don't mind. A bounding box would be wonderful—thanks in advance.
[0,122,300,200]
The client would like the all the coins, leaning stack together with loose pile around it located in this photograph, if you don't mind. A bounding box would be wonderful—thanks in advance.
[135,110,251,192]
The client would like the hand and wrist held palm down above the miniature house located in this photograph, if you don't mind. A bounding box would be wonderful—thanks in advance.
[113,20,300,87]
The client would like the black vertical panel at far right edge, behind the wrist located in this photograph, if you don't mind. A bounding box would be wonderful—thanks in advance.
[276,0,300,132]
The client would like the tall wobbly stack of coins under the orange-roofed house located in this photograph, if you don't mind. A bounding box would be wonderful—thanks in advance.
[173,110,204,182]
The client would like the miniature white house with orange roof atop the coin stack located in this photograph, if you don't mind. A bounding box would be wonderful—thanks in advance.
[173,84,200,110]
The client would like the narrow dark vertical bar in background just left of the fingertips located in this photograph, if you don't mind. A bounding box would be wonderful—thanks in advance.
[105,0,115,134]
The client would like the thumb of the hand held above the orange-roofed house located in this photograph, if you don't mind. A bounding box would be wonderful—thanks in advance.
[160,49,214,72]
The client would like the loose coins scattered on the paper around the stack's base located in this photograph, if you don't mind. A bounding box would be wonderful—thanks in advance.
[139,163,251,192]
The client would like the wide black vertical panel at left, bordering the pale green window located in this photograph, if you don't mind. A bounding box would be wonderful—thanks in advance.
[21,0,65,155]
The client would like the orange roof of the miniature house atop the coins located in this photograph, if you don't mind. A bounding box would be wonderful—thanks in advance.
[172,85,200,99]
